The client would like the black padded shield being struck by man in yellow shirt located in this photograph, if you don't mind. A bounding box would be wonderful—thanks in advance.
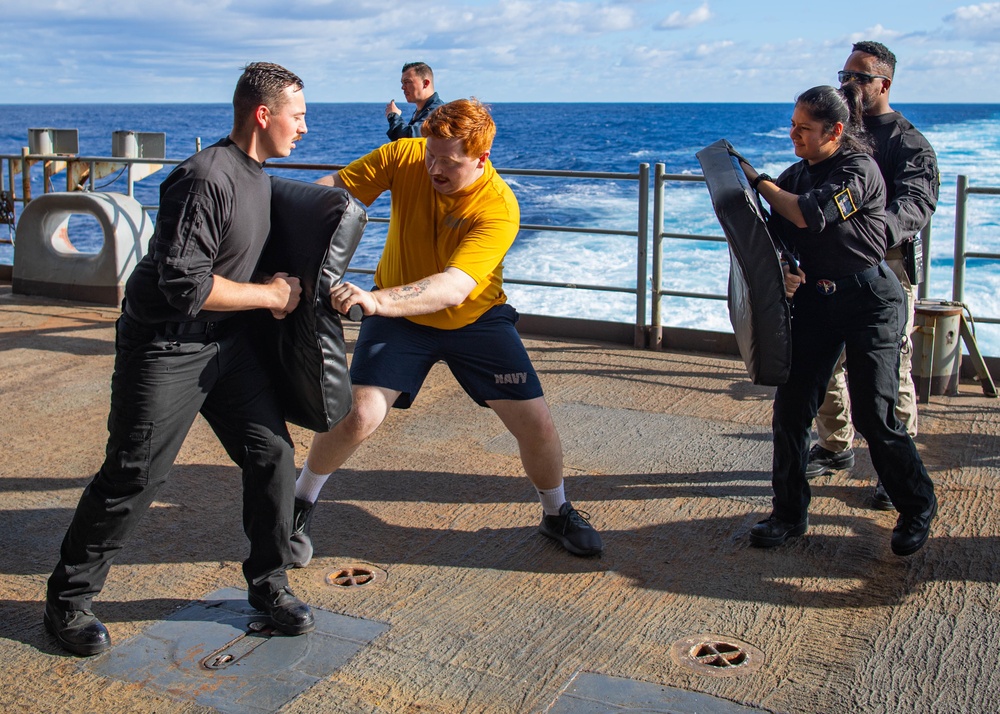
[258,176,368,431]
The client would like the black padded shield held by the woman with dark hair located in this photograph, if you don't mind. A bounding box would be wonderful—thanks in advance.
[696,139,792,386]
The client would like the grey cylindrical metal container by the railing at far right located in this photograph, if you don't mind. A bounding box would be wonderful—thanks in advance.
[911,300,962,402]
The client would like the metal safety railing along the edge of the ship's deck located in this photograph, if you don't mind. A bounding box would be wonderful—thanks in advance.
[0,153,1000,348]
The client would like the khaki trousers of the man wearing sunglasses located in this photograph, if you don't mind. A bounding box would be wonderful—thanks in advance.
[816,248,917,454]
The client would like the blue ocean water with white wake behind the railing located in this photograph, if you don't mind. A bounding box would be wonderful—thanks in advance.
[0,103,1000,355]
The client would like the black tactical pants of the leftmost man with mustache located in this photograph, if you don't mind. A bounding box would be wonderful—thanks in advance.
[48,314,296,610]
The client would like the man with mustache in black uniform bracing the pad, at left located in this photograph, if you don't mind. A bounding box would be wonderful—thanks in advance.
[44,63,314,655]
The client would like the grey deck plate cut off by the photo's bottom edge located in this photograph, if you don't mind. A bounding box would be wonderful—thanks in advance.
[547,672,768,714]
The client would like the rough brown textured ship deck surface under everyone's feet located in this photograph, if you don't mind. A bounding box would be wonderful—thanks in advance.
[0,286,1000,713]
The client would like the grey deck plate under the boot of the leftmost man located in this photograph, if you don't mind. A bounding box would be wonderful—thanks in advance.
[83,588,389,714]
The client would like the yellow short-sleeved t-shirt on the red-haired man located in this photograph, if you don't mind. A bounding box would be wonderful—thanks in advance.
[339,139,521,330]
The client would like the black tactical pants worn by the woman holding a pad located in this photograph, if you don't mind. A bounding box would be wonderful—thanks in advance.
[771,264,934,523]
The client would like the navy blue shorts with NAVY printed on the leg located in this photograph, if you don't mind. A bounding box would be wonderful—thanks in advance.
[351,304,542,409]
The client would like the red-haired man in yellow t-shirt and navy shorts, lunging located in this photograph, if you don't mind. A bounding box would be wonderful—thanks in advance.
[291,99,604,567]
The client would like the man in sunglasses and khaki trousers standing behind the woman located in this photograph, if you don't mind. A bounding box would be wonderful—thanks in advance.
[806,41,940,511]
